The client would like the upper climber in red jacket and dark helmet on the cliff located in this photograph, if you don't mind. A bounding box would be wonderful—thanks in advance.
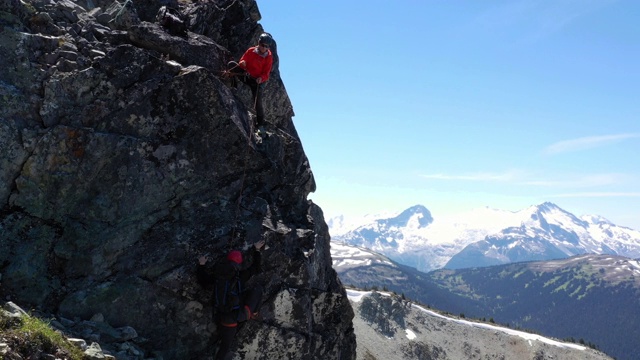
[228,34,273,132]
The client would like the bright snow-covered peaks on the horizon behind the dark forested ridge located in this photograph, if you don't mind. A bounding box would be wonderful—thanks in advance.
[328,202,640,271]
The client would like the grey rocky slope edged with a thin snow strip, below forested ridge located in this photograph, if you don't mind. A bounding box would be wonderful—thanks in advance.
[350,290,612,360]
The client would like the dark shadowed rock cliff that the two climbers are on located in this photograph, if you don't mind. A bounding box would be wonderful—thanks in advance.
[0,0,355,359]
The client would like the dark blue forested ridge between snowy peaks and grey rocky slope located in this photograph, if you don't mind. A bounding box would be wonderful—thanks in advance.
[331,242,640,360]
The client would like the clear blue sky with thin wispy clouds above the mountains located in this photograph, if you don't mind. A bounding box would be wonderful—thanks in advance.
[258,0,640,229]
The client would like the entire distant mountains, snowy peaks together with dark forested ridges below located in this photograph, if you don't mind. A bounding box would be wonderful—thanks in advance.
[327,203,640,360]
